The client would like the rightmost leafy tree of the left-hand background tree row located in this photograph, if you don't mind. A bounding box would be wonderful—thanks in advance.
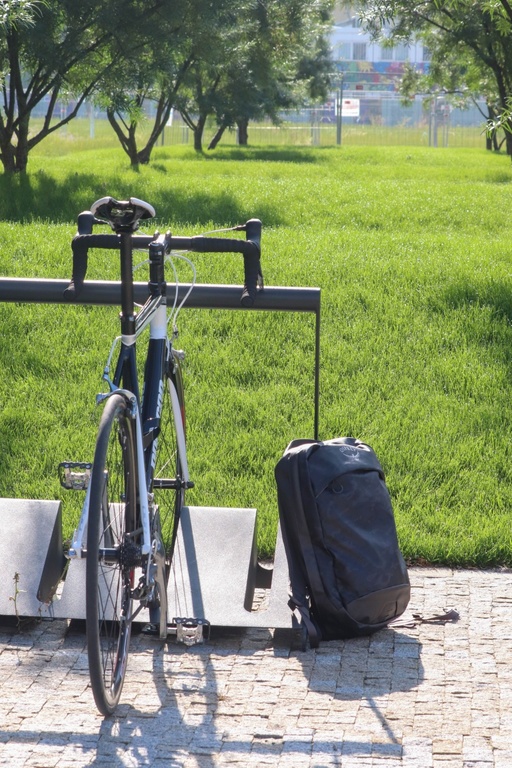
[175,0,332,149]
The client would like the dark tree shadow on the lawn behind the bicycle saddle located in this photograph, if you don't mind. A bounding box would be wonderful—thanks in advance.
[0,164,282,226]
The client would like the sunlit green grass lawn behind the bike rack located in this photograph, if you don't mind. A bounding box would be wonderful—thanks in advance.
[0,145,512,566]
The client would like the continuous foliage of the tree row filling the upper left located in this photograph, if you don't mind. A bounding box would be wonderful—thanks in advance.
[0,0,333,173]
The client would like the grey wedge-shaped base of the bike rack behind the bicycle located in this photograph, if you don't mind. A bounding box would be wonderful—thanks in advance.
[0,499,294,628]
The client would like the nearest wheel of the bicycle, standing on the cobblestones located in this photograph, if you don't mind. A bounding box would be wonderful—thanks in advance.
[86,395,140,715]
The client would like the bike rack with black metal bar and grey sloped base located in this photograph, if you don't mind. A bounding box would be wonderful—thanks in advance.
[0,278,320,642]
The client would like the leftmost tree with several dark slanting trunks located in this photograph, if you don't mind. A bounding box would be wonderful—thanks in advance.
[0,0,197,173]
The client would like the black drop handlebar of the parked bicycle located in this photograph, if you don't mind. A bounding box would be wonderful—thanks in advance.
[64,211,263,307]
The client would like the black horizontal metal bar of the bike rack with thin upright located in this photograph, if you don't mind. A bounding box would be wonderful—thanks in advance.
[0,277,320,440]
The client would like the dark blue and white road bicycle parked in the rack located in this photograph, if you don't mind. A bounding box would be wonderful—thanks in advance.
[59,197,263,716]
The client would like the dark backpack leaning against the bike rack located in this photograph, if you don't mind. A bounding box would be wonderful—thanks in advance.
[275,437,410,647]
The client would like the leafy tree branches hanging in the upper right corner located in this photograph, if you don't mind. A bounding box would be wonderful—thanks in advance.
[357,0,512,154]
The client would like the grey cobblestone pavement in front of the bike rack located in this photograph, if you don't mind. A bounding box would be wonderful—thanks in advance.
[0,569,512,768]
